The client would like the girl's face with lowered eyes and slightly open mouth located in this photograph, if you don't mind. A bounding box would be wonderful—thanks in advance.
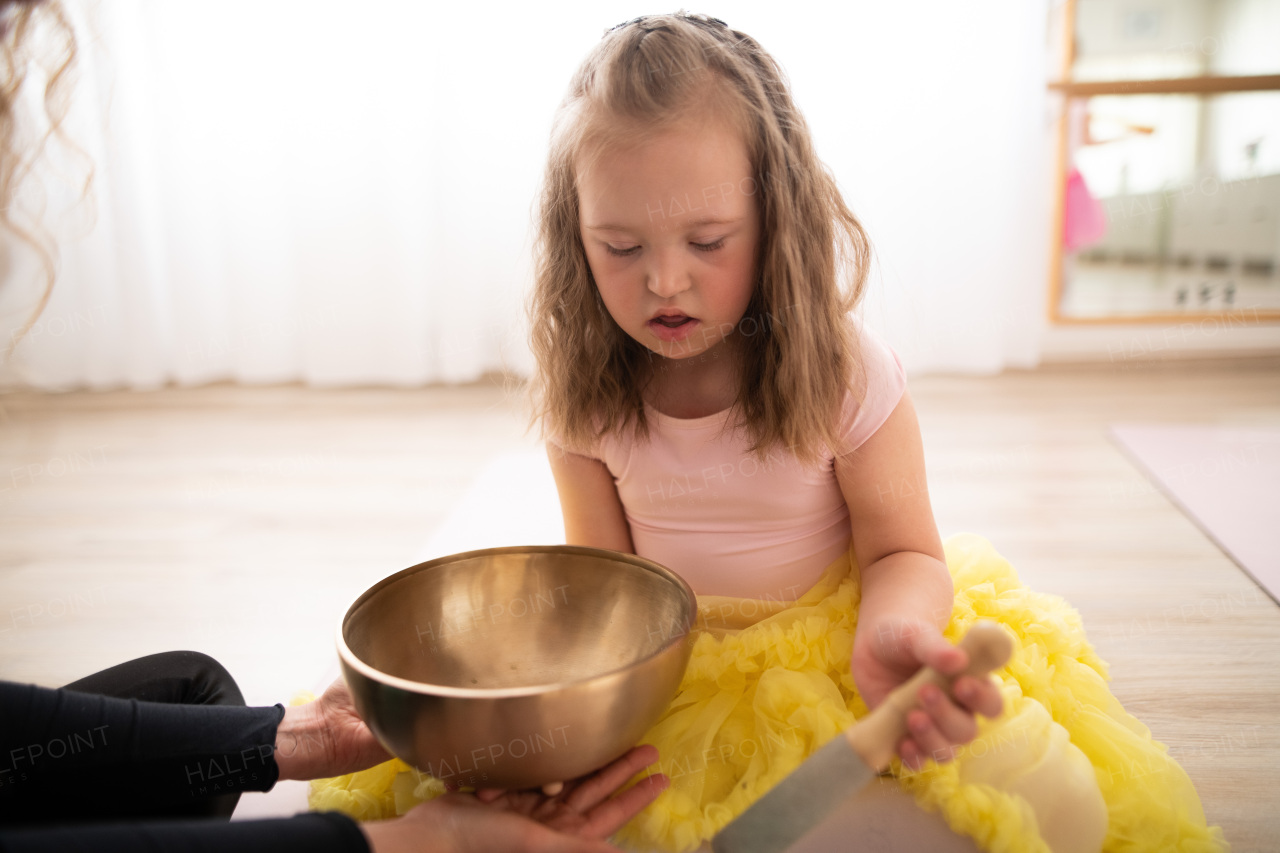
[577,123,759,359]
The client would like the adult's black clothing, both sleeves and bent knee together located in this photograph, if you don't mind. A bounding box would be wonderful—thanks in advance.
[0,652,369,853]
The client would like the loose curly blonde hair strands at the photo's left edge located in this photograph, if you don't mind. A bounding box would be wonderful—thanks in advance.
[0,0,79,360]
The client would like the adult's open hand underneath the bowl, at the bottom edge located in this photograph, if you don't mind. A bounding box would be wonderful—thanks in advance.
[361,745,669,853]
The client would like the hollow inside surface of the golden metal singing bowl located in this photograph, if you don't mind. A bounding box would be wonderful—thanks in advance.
[343,547,694,689]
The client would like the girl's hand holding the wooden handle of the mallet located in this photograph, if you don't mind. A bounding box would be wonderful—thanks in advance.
[851,617,1004,770]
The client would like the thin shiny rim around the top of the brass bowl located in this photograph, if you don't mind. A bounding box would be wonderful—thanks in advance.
[338,544,698,699]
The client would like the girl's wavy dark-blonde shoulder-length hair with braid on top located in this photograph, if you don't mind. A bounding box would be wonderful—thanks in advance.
[527,10,870,462]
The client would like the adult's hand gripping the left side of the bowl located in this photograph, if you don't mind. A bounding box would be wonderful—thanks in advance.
[275,679,392,780]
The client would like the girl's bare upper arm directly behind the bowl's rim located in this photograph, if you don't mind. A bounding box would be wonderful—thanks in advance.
[547,442,635,553]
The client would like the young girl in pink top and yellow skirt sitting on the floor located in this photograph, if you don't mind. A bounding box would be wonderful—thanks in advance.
[312,13,1221,853]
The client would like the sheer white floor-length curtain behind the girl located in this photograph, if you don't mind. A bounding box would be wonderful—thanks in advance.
[0,0,1051,389]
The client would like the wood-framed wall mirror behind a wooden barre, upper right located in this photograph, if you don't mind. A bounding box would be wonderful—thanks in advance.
[1051,0,1280,321]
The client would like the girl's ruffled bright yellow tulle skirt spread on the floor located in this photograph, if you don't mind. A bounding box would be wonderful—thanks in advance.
[302,534,1229,853]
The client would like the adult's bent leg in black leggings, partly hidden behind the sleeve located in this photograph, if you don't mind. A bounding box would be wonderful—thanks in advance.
[64,652,244,820]
